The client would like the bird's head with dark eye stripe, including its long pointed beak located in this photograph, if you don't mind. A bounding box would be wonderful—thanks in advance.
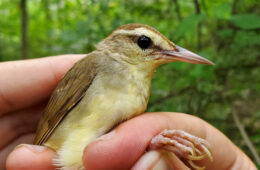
[97,24,213,67]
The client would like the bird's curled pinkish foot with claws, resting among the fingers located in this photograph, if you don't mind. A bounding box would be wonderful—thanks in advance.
[149,130,213,169]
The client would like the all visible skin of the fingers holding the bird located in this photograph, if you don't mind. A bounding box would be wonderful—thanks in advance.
[0,55,256,170]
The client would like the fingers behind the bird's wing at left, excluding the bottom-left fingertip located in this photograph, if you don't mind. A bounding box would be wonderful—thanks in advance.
[0,55,85,169]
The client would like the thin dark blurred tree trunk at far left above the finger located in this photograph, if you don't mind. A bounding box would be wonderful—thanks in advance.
[21,0,28,59]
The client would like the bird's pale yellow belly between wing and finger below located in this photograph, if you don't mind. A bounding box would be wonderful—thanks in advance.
[45,80,148,169]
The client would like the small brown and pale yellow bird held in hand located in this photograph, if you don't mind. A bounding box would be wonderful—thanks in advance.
[34,23,214,169]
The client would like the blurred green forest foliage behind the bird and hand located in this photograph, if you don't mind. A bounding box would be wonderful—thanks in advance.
[0,0,260,167]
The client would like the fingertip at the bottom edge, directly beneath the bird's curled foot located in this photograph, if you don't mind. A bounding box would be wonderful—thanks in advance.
[131,150,189,170]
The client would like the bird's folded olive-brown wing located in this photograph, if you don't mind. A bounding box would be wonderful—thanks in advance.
[34,55,96,145]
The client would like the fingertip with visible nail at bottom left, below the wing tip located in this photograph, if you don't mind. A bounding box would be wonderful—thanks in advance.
[6,144,55,170]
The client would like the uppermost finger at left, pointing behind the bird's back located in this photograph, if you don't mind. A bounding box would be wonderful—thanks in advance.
[0,55,85,115]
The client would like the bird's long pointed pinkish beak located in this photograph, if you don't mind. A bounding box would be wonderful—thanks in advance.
[161,45,215,65]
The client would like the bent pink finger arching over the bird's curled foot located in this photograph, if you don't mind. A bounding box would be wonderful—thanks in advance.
[83,113,236,169]
